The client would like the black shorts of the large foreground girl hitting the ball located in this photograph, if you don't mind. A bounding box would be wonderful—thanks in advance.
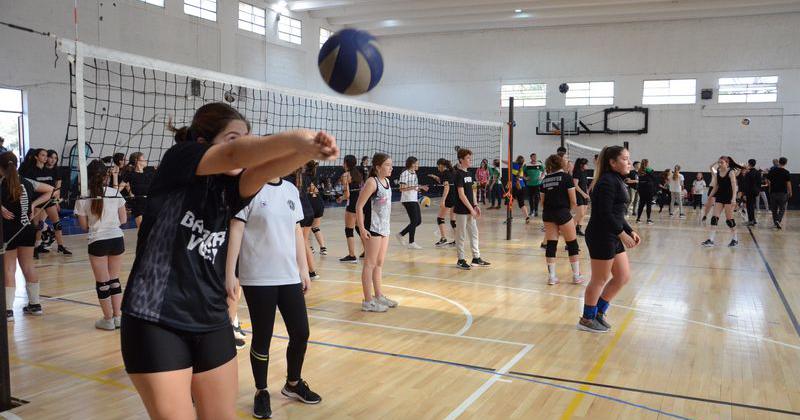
[120,314,236,374]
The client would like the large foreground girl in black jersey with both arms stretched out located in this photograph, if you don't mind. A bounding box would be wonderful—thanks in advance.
[121,103,339,420]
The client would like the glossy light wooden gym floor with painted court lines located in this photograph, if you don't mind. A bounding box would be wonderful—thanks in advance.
[1,205,800,419]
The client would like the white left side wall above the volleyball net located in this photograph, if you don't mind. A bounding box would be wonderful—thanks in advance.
[0,0,330,152]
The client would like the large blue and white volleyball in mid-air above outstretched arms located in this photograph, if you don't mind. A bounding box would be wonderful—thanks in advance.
[317,29,383,95]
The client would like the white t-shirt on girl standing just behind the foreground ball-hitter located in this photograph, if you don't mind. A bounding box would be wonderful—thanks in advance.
[236,180,303,286]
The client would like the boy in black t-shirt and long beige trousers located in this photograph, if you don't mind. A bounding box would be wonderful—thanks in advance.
[453,149,489,270]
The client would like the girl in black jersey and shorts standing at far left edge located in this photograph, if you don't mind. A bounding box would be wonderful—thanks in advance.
[0,152,53,322]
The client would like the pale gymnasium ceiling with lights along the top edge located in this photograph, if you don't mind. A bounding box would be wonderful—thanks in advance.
[287,0,800,36]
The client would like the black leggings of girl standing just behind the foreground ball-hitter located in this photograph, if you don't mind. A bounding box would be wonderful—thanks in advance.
[242,283,309,389]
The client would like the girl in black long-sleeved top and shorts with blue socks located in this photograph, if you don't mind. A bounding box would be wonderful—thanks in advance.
[578,146,640,333]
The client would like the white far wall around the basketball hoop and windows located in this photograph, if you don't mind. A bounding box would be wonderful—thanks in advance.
[370,14,800,172]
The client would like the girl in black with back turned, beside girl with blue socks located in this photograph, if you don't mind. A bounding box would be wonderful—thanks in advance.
[541,155,585,285]
